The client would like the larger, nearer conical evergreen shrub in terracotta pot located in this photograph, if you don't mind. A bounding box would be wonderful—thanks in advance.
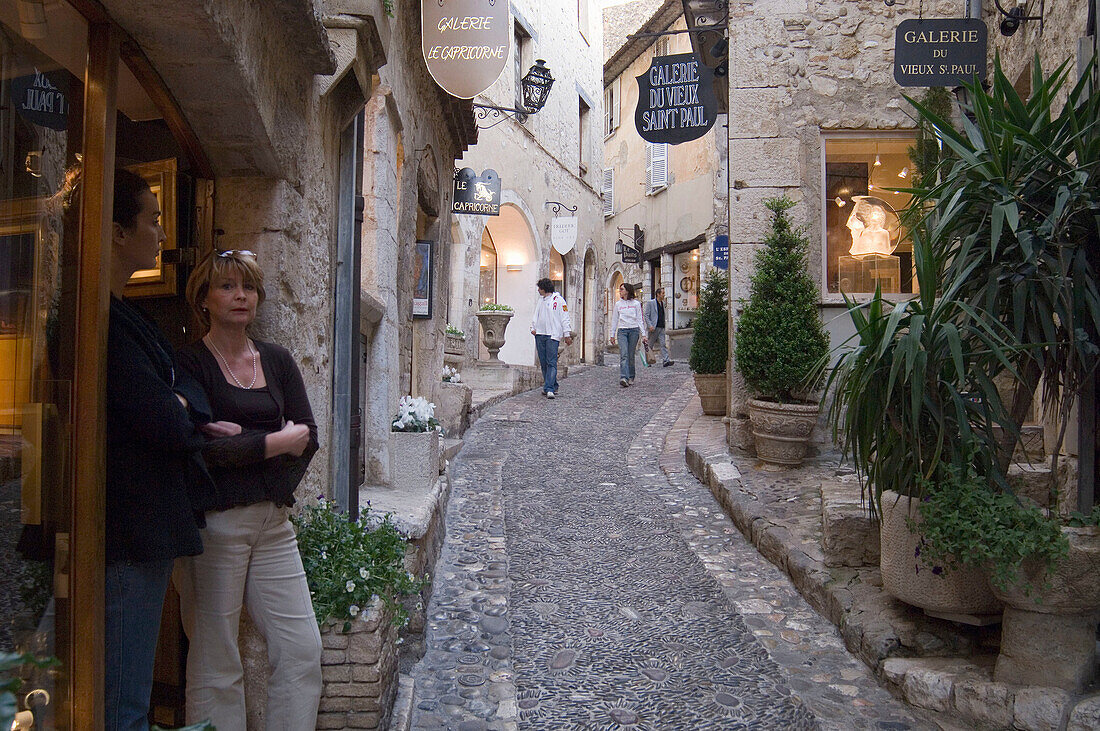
[734,196,828,465]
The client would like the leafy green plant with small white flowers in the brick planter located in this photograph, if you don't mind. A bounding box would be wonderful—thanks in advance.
[290,497,428,632]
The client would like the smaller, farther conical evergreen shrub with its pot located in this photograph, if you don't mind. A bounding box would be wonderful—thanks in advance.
[688,269,729,417]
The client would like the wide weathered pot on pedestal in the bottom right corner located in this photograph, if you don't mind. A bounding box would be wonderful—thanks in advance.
[993,527,1100,693]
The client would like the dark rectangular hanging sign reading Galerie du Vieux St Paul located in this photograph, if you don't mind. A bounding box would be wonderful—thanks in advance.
[894,18,989,87]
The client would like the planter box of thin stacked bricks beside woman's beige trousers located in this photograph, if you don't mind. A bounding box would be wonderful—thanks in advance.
[317,600,397,729]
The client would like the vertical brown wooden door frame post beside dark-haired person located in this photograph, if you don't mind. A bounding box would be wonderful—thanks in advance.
[68,23,121,731]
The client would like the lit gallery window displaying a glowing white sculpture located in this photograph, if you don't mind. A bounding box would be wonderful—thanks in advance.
[824,134,914,293]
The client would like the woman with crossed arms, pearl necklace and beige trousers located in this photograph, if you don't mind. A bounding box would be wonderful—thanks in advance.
[176,251,321,731]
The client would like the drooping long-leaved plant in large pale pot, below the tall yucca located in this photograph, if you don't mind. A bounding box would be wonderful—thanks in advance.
[820,219,1014,513]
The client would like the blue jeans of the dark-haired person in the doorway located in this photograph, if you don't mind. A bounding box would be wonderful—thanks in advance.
[103,560,172,731]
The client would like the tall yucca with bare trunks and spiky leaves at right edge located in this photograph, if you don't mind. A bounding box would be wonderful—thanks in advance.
[910,56,1100,479]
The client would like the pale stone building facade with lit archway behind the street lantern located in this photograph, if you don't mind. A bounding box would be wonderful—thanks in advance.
[443,0,607,366]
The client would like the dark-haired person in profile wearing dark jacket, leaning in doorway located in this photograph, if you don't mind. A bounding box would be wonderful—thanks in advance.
[103,170,213,731]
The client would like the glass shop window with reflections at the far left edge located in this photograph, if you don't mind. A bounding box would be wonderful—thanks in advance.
[0,1,88,716]
